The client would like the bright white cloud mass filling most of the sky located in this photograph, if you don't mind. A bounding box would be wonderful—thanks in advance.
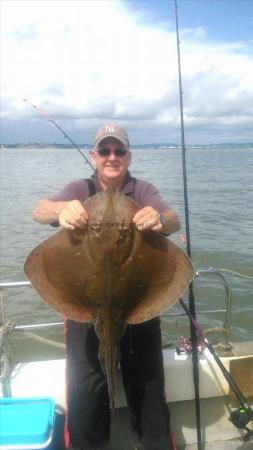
[1,0,253,141]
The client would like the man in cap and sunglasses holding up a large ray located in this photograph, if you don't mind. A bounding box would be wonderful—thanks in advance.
[33,123,180,450]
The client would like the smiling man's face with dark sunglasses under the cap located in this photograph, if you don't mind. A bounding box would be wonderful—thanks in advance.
[91,138,131,183]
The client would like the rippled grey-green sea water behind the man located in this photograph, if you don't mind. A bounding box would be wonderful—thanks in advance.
[0,146,253,360]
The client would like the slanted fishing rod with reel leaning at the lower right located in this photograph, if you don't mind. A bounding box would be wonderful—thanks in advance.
[179,298,253,441]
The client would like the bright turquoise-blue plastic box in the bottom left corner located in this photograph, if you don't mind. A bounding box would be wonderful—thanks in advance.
[0,397,55,450]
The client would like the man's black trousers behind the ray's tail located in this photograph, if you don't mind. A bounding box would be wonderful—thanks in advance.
[66,318,170,450]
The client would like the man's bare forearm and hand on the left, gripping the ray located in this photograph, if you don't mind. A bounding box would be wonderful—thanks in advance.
[32,199,88,230]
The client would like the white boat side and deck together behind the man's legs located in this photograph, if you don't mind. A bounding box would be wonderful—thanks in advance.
[3,343,253,450]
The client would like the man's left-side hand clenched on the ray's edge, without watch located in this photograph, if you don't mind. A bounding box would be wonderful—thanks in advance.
[59,200,88,230]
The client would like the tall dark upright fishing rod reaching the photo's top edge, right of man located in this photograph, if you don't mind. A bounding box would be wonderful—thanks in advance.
[175,0,202,450]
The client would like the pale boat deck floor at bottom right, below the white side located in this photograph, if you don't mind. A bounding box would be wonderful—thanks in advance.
[108,397,253,450]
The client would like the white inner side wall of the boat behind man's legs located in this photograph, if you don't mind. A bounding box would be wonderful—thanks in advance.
[6,344,253,407]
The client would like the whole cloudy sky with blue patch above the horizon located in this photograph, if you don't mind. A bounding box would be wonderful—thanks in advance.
[0,0,253,145]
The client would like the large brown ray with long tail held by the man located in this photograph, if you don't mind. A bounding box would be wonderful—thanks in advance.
[24,189,193,406]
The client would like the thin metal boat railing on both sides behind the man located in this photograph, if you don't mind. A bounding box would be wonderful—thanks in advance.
[0,267,232,341]
